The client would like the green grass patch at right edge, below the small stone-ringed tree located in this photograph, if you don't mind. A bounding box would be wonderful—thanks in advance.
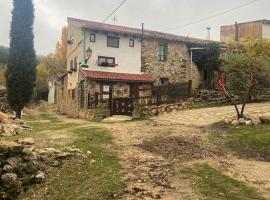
[211,125,270,161]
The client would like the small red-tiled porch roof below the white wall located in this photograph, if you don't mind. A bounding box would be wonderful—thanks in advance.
[80,68,155,83]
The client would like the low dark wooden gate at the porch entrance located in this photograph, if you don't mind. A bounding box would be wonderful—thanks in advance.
[112,98,134,116]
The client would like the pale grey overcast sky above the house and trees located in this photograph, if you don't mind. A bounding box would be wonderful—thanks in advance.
[0,0,270,54]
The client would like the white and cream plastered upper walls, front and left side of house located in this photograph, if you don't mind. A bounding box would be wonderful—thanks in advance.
[67,24,141,90]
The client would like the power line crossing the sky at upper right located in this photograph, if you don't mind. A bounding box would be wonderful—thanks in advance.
[164,0,260,31]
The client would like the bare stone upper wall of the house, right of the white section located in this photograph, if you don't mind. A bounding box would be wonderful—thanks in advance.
[142,38,200,88]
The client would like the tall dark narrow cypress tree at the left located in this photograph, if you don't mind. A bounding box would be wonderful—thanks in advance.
[6,0,36,118]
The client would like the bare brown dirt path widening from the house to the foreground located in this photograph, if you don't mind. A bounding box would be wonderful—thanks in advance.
[39,103,270,200]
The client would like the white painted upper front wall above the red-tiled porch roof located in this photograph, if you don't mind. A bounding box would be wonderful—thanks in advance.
[86,32,141,74]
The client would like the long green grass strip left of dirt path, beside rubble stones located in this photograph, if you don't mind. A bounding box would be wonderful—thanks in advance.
[16,110,125,200]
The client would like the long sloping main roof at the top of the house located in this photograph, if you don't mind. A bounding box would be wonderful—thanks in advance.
[68,17,213,44]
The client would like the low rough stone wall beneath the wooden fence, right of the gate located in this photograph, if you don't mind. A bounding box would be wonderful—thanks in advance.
[142,101,192,116]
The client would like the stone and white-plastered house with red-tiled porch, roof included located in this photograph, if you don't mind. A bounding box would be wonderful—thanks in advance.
[57,18,212,119]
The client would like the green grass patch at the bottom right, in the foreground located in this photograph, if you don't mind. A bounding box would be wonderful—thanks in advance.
[181,164,264,200]
